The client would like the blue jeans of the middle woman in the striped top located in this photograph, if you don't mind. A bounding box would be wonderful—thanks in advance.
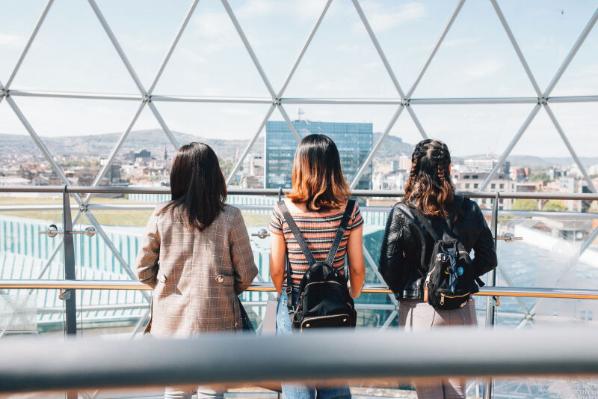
[276,291,351,399]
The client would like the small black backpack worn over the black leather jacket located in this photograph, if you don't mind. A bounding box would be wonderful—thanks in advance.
[399,204,484,310]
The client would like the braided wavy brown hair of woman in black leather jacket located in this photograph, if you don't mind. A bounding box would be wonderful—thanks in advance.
[404,139,455,217]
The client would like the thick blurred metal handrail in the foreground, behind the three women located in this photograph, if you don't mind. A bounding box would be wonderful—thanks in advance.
[0,327,598,393]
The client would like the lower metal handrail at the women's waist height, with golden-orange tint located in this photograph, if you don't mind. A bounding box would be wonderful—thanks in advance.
[0,280,598,300]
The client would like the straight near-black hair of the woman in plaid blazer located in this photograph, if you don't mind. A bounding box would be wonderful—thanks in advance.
[163,142,226,230]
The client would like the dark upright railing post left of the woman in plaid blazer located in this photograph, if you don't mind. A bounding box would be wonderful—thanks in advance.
[62,185,78,399]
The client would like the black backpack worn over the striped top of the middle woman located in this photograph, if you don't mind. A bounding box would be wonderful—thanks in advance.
[279,200,357,330]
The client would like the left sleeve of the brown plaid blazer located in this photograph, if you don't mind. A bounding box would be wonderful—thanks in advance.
[135,210,160,288]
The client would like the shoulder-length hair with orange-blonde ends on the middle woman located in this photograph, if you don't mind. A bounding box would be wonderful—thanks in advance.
[288,134,350,211]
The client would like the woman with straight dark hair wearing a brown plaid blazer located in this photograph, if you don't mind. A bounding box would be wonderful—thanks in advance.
[136,143,258,398]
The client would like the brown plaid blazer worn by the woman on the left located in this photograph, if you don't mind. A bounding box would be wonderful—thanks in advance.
[136,205,258,337]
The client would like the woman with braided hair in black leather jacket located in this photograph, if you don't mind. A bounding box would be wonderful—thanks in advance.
[379,139,496,399]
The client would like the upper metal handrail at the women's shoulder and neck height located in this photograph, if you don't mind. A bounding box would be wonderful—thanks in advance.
[0,186,598,201]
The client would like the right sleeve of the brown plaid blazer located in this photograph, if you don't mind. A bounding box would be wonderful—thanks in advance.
[229,208,258,294]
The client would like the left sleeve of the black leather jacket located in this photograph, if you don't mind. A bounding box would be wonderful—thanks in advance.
[379,205,421,292]
